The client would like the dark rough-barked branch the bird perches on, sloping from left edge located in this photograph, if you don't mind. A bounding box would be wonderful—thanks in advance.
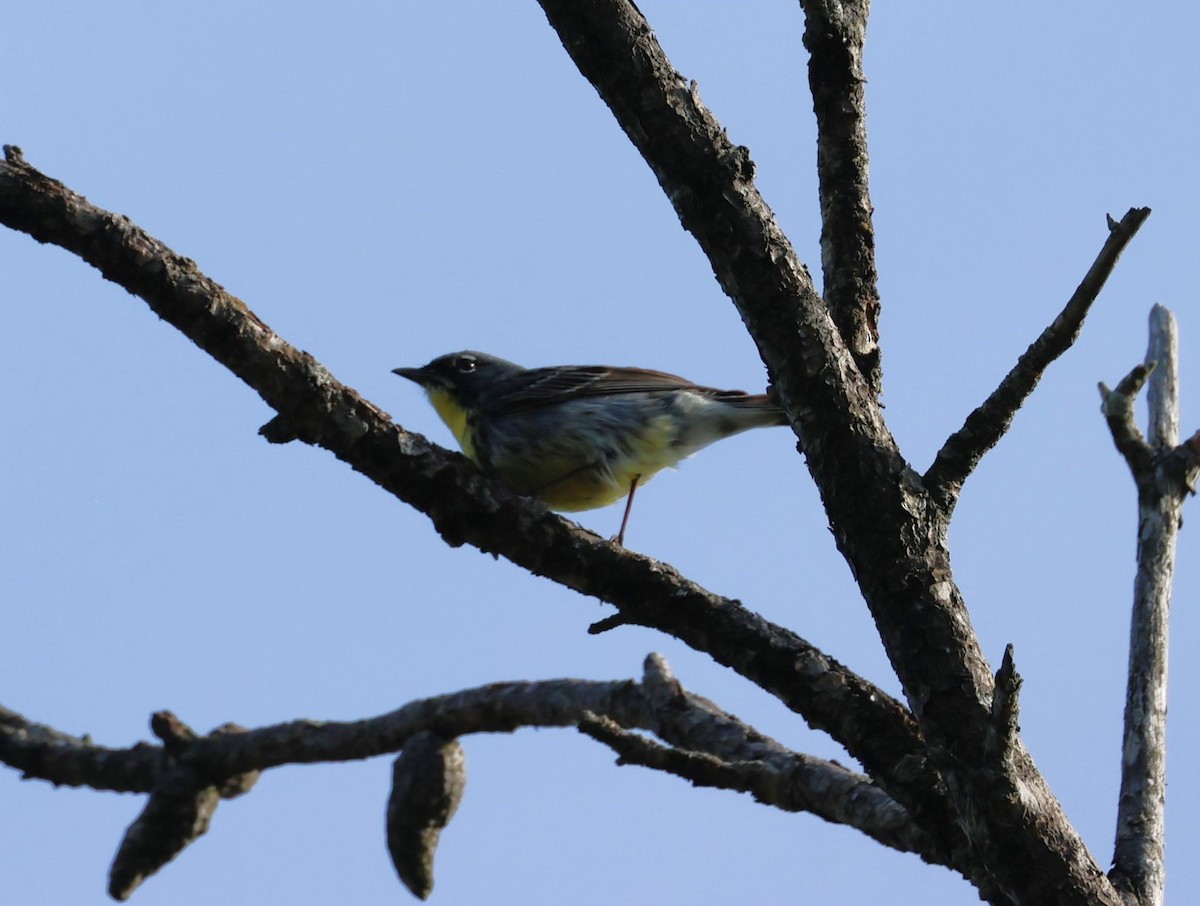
[0,150,960,851]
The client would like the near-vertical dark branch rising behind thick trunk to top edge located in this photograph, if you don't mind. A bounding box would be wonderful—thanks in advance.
[800,0,883,396]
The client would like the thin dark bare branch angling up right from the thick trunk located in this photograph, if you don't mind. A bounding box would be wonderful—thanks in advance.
[924,208,1150,515]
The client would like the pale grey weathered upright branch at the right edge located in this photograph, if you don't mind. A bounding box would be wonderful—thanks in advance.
[1102,305,1200,906]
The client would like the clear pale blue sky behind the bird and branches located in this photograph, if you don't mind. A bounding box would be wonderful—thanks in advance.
[0,0,1200,906]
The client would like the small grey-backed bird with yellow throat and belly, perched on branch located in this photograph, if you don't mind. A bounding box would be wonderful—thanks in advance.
[392,349,787,545]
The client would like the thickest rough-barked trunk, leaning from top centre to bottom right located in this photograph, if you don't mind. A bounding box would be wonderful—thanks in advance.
[540,8,1118,904]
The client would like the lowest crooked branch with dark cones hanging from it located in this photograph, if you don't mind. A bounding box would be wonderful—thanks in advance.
[0,655,955,900]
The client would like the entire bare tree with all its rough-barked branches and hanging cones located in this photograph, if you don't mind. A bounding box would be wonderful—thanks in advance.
[0,0,1185,906]
